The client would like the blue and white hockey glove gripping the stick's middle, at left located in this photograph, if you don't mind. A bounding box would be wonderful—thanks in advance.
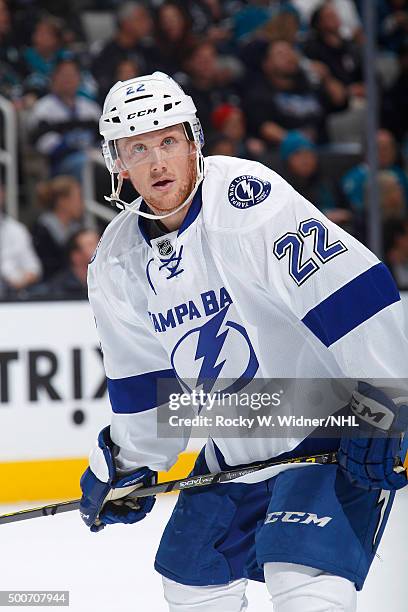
[79,427,157,532]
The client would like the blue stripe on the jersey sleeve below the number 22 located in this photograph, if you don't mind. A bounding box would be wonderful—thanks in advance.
[302,263,400,346]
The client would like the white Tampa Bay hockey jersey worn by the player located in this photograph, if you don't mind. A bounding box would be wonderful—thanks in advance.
[88,156,408,470]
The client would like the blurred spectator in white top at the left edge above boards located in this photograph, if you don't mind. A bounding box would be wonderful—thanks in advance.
[0,184,41,297]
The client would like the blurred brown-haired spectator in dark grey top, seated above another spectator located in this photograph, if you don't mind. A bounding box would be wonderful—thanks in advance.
[32,176,84,281]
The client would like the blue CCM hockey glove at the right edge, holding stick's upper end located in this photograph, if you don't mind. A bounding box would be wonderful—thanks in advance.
[338,382,408,491]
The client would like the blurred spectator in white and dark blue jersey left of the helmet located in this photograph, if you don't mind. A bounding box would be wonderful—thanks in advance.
[29,60,101,180]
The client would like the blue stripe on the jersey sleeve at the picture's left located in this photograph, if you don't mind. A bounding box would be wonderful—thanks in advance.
[107,369,182,414]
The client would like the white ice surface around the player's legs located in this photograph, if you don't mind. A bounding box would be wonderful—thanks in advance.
[0,490,408,612]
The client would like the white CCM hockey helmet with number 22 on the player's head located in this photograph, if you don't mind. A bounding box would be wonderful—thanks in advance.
[99,72,204,179]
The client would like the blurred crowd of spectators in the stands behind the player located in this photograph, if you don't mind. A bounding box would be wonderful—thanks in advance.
[0,0,408,297]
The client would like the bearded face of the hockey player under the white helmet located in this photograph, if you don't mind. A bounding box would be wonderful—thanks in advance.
[117,125,196,215]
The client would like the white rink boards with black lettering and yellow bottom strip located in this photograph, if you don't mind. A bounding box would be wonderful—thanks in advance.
[0,295,408,503]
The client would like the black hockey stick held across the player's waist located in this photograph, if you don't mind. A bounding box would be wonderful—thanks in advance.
[0,451,402,525]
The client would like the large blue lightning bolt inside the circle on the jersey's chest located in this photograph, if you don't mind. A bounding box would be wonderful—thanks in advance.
[195,305,229,393]
